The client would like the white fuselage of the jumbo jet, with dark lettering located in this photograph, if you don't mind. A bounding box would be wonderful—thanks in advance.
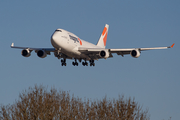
[51,29,100,59]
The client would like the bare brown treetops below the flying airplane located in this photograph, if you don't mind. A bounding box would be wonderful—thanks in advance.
[0,85,149,120]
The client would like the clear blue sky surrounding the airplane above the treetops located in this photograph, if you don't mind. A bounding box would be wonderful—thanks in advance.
[0,0,180,120]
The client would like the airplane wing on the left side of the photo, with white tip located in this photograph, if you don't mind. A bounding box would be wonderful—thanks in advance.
[11,43,56,54]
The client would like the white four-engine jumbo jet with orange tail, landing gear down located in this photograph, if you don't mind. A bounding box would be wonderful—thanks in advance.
[11,24,174,66]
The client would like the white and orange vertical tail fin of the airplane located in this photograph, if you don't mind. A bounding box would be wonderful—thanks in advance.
[96,24,109,48]
